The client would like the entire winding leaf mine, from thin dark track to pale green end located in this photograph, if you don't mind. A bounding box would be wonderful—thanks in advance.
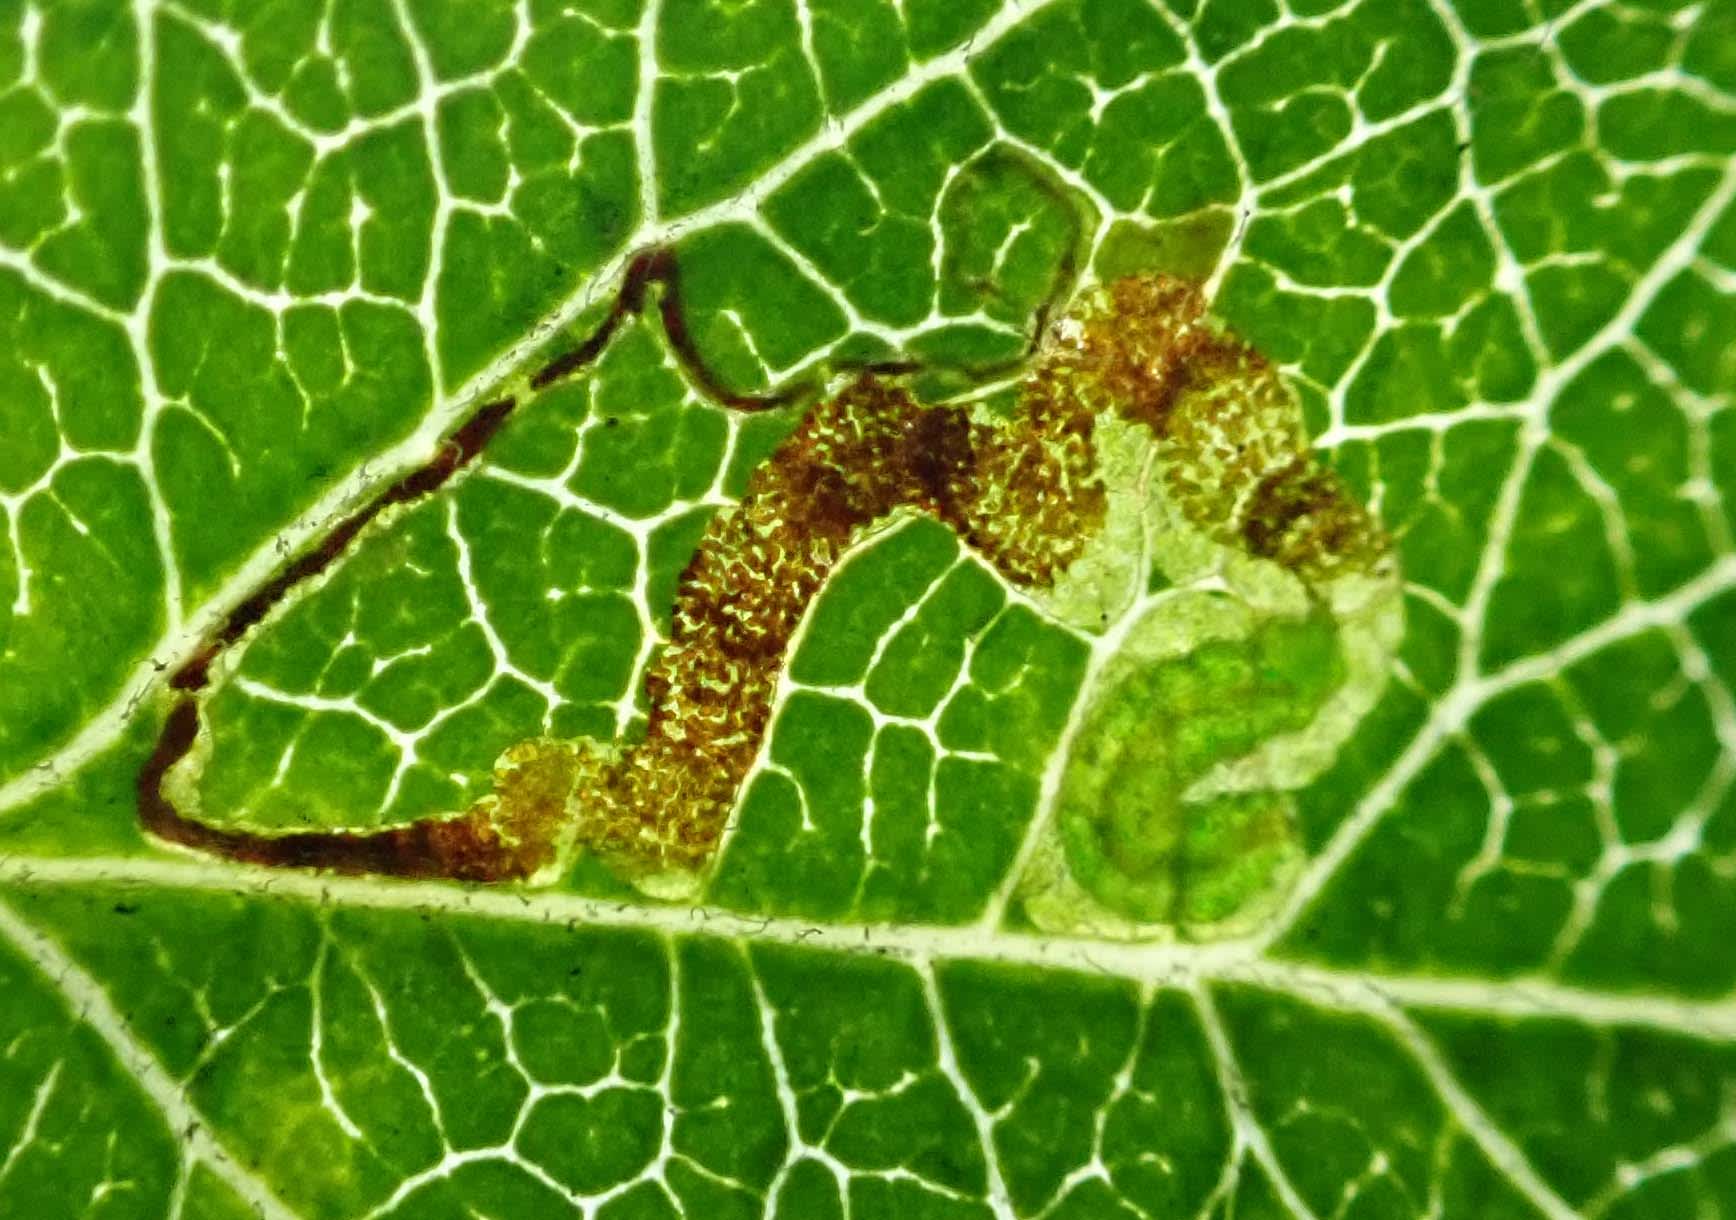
[141,264,1399,937]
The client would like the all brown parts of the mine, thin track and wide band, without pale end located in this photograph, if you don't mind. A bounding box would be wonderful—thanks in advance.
[139,267,1385,880]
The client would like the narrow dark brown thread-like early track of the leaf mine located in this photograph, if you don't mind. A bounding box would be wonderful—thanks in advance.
[137,222,1078,882]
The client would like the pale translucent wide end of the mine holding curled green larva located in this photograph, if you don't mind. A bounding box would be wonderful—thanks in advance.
[1016,288,1403,941]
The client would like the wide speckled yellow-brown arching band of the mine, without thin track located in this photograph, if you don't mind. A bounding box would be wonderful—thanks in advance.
[502,276,1384,871]
